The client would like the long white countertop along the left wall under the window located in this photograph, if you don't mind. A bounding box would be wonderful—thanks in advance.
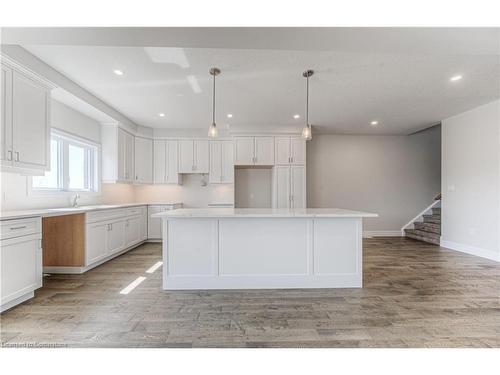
[0,202,182,220]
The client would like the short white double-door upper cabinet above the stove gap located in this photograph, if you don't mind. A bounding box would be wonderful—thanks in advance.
[178,139,209,173]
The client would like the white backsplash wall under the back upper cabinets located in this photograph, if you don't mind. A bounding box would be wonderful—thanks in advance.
[135,174,234,208]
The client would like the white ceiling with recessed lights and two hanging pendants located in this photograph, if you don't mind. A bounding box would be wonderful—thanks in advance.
[14,29,500,134]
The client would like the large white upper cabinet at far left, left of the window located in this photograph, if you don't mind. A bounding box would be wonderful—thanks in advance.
[0,62,53,175]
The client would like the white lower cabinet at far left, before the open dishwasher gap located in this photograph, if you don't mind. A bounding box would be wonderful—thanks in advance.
[0,218,43,311]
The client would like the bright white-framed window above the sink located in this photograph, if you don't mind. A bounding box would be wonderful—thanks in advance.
[32,130,99,192]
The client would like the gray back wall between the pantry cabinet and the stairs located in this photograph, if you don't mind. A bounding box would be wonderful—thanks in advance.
[307,126,441,231]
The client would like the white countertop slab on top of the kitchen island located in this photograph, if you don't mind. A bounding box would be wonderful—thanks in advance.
[151,208,378,218]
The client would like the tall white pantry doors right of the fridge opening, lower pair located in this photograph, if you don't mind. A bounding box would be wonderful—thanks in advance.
[272,166,306,208]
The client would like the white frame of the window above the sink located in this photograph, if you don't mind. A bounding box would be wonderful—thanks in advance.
[28,128,101,196]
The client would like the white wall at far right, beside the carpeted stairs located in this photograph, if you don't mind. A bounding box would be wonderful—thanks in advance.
[441,100,500,261]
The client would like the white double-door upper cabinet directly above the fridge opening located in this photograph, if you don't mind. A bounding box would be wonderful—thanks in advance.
[234,137,274,165]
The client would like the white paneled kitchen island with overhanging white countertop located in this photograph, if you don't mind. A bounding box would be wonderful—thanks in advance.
[153,208,378,290]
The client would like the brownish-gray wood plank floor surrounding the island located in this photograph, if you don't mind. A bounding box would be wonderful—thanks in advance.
[0,238,500,347]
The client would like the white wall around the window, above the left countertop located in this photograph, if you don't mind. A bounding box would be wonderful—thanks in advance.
[0,100,135,211]
